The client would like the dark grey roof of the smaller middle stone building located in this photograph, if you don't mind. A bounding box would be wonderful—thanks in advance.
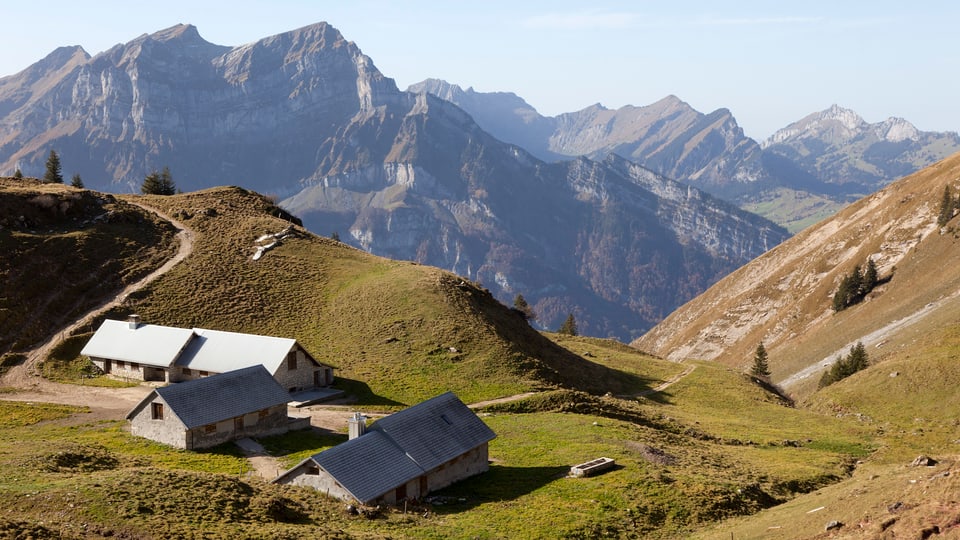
[127,365,290,429]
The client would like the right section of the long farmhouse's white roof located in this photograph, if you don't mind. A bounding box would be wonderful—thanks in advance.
[177,328,296,375]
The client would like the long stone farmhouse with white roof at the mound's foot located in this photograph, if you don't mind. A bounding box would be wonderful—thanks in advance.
[80,315,333,392]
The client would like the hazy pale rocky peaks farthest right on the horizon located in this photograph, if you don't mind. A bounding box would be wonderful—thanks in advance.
[763,105,960,194]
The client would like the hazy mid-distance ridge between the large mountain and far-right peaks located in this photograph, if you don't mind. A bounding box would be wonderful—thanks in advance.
[409,83,796,200]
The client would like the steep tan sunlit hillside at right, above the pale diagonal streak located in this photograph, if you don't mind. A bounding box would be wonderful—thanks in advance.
[635,155,960,397]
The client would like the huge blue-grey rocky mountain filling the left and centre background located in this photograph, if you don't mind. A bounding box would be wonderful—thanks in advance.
[0,23,788,340]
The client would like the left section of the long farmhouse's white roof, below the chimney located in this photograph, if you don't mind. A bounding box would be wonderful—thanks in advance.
[80,319,193,367]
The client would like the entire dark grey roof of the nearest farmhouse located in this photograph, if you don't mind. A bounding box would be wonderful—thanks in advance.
[296,392,497,503]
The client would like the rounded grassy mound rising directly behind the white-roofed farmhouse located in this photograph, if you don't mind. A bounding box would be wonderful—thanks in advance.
[107,188,650,405]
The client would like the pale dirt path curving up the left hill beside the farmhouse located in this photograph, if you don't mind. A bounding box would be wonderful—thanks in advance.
[0,203,194,418]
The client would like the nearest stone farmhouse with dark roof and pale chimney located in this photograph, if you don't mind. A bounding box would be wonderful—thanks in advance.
[274,392,496,505]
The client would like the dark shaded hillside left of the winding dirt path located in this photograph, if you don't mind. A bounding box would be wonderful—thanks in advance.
[0,178,175,356]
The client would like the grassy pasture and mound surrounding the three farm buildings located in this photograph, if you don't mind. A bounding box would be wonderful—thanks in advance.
[0,180,878,538]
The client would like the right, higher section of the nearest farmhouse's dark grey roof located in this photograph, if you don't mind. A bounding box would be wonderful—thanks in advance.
[370,392,497,471]
